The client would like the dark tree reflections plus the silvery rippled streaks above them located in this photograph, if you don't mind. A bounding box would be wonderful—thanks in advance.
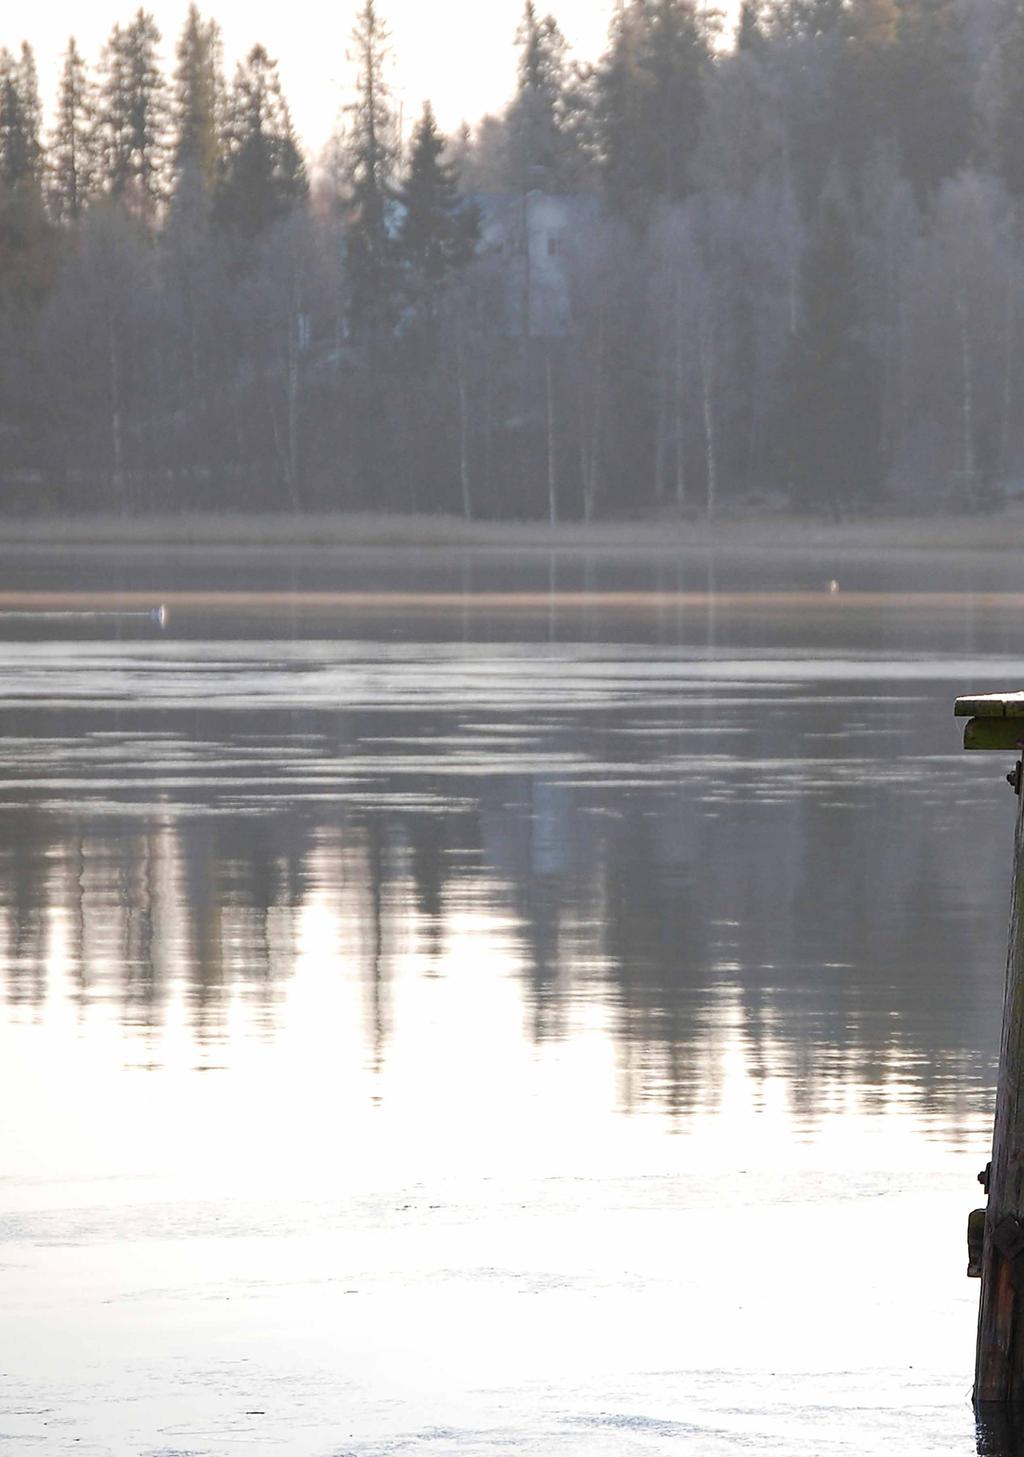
[0,626,1014,1139]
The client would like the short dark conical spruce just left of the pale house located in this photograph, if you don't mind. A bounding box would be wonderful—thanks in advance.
[396,102,479,299]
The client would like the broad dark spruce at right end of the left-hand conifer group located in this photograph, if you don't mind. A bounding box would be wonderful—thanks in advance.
[214,45,309,237]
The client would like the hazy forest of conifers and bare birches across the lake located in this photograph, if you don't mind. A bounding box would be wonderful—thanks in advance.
[0,0,1024,519]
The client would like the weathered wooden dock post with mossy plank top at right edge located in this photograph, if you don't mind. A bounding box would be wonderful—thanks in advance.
[956,694,1024,1416]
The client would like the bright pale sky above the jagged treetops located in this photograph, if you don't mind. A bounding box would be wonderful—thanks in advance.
[22,0,615,156]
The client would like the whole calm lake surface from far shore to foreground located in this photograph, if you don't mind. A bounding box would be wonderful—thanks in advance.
[0,551,1024,1457]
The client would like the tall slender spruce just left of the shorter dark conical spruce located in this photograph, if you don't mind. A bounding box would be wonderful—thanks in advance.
[345,0,398,344]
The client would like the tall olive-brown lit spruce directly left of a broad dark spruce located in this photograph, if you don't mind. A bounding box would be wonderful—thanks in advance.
[172,4,224,194]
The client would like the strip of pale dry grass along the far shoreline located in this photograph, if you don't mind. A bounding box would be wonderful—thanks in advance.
[0,511,1024,555]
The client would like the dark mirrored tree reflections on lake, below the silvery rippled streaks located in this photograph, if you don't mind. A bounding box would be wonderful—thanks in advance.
[0,722,1005,1132]
